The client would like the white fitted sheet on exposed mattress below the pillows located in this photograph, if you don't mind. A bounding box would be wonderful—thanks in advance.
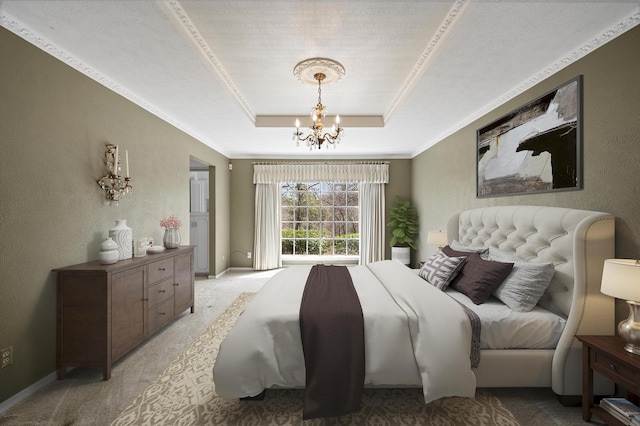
[445,289,566,348]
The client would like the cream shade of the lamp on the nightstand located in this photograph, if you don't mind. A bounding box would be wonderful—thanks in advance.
[600,259,640,302]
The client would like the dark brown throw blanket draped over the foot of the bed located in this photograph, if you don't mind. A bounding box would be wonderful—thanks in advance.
[300,265,365,419]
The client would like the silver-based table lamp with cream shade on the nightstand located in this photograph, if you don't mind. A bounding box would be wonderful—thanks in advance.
[600,259,640,355]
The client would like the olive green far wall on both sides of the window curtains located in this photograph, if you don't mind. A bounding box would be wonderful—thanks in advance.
[231,159,413,267]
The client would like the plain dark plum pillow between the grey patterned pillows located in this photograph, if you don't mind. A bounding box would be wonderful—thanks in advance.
[442,246,513,305]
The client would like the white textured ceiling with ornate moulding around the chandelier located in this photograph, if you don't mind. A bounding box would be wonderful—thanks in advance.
[0,0,640,159]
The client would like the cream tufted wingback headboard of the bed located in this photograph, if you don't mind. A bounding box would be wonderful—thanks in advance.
[447,206,615,395]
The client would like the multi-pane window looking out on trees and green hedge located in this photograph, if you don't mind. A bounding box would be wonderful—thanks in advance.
[282,182,360,256]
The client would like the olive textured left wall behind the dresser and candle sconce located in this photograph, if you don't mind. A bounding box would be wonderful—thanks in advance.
[0,28,229,402]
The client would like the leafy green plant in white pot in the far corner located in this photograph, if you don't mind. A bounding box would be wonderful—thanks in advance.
[387,195,418,265]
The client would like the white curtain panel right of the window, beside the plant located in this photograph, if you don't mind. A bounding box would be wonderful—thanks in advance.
[358,183,386,265]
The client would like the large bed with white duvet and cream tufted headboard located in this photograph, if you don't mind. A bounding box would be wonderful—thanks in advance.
[213,206,615,408]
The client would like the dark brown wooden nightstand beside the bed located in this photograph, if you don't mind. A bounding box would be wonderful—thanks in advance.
[576,336,640,425]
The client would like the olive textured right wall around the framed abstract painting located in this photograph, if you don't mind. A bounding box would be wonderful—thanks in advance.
[412,27,640,321]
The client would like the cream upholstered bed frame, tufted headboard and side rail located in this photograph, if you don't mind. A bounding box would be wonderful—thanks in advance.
[447,206,615,401]
